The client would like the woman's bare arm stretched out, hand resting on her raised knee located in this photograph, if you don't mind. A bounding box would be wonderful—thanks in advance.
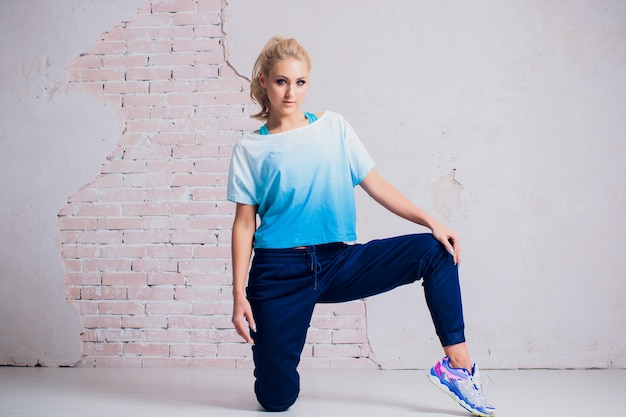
[360,169,461,264]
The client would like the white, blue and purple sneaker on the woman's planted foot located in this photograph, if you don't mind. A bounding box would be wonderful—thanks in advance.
[428,356,496,417]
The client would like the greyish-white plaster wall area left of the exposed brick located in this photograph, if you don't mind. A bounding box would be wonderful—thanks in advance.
[0,0,143,366]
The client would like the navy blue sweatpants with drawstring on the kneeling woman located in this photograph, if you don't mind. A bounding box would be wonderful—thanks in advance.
[247,234,465,411]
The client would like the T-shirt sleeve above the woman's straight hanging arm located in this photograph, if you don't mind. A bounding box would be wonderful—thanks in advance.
[226,144,258,205]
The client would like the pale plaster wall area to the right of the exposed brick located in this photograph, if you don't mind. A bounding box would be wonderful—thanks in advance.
[224,0,626,368]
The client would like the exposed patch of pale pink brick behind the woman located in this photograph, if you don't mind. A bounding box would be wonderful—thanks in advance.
[57,0,376,368]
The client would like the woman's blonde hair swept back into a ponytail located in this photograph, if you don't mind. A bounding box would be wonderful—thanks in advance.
[250,36,311,120]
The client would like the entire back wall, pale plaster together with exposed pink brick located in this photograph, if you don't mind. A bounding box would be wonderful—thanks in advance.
[0,0,626,368]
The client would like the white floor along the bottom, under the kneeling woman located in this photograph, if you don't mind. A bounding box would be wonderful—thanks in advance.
[0,367,626,417]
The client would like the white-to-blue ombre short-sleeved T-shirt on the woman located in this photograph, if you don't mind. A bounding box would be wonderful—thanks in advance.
[227,111,374,248]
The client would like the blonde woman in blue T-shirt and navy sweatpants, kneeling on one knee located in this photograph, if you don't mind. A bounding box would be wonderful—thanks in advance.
[228,37,495,416]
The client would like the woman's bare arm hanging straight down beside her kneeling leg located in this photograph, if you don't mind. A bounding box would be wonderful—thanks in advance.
[231,204,257,343]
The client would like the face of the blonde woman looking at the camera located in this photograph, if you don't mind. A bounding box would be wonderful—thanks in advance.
[259,58,309,116]
